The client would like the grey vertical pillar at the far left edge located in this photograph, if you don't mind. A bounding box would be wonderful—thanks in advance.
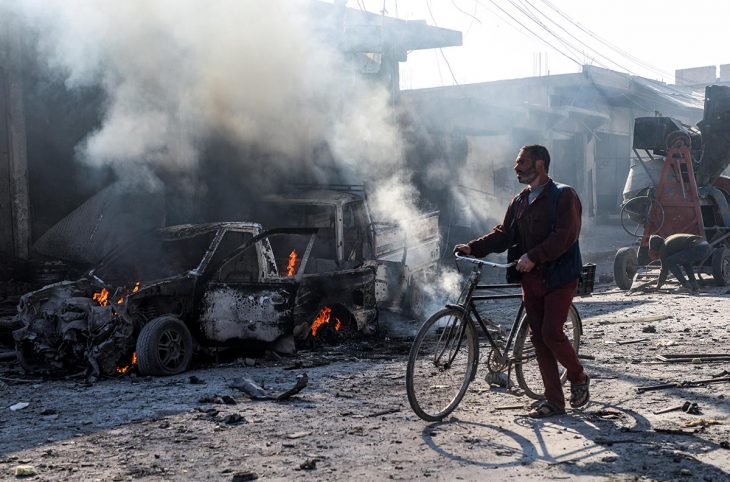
[0,6,30,258]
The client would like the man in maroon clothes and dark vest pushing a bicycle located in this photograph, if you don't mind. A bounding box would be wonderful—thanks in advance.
[454,145,590,418]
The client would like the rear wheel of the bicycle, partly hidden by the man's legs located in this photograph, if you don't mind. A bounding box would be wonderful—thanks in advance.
[514,305,581,400]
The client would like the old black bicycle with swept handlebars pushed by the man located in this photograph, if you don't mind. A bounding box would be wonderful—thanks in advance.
[406,255,584,422]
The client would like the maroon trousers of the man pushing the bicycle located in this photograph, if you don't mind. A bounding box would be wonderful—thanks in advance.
[522,272,585,408]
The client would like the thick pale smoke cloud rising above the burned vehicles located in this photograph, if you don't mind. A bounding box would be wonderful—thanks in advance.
[10,0,418,226]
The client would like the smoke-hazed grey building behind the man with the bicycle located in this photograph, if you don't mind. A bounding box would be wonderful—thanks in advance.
[401,65,714,244]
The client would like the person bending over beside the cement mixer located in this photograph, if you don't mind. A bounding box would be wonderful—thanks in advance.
[649,233,712,292]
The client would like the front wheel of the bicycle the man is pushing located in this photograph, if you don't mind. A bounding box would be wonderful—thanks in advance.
[406,308,479,422]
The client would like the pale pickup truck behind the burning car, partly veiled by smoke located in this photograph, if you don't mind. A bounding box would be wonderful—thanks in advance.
[266,184,441,315]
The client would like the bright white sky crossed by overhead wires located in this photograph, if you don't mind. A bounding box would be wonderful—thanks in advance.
[347,0,730,89]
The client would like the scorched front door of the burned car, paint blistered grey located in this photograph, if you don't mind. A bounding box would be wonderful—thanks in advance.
[199,231,297,345]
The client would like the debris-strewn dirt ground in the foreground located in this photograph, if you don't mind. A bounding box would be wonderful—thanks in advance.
[0,274,730,481]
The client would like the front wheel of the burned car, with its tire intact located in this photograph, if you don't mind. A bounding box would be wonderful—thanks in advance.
[137,315,193,376]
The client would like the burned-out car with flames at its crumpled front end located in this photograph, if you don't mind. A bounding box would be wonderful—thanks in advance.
[13,222,377,378]
